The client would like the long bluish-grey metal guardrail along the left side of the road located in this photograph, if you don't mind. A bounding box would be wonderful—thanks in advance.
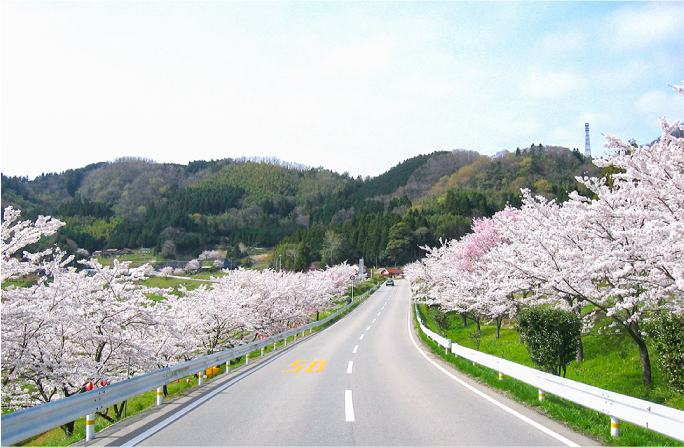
[0,284,380,446]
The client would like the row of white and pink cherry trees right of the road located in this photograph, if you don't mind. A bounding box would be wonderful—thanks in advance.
[405,87,684,386]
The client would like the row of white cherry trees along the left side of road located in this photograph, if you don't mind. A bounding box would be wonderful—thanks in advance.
[1,212,353,418]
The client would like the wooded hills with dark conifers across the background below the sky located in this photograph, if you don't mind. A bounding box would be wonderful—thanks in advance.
[2,145,599,269]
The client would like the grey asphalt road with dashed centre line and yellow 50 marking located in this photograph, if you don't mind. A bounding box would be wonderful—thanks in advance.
[91,280,595,446]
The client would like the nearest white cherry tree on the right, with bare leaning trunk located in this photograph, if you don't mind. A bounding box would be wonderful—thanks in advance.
[567,114,684,386]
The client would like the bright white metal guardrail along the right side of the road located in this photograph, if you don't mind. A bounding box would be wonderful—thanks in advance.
[416,300,684,441]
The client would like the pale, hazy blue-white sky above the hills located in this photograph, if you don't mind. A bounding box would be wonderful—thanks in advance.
[0,0,684,179]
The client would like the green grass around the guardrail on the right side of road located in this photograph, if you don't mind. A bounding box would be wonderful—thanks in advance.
[415,305,684,446]
